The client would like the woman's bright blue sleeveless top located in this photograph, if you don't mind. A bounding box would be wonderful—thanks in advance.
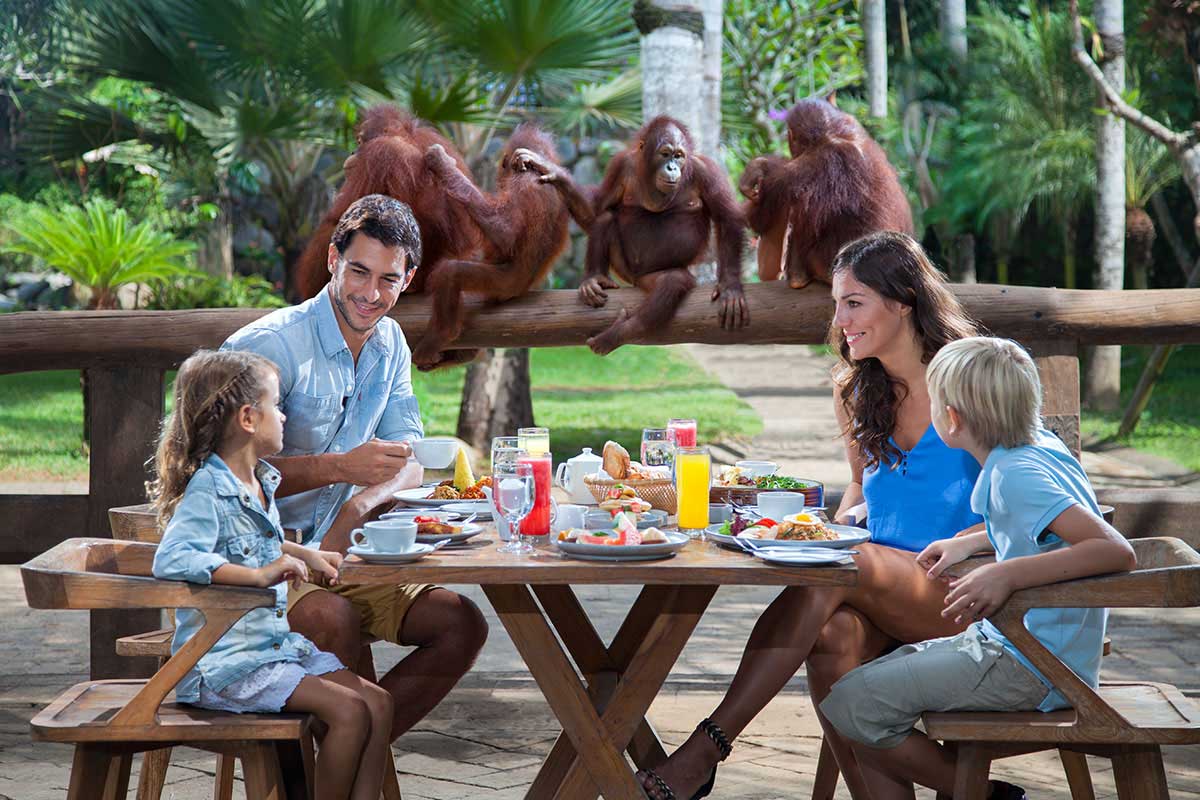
[863,425,983,552]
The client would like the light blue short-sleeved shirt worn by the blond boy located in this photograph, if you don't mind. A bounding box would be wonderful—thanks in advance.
[971,429,1109,711]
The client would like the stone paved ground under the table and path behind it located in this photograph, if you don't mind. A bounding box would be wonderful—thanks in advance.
[0,347,1200,800]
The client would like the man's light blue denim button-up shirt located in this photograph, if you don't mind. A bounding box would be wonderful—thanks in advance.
[221,288,424,547]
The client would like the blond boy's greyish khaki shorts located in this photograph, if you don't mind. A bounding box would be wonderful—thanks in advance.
[821,625,1049,748]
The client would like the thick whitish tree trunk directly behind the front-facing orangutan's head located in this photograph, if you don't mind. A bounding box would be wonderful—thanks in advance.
[642,0,704,137]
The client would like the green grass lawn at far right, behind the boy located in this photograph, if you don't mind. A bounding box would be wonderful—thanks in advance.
[1081,345,1200,470]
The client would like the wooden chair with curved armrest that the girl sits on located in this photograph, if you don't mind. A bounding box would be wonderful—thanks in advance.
[20,539,313,800]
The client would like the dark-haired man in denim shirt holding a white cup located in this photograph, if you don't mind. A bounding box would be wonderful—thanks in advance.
[223,194,487,739]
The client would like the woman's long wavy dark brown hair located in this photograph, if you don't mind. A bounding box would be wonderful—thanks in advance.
[828,231,979,467]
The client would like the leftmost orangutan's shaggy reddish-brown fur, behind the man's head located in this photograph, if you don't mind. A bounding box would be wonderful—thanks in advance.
[294,106,480,297]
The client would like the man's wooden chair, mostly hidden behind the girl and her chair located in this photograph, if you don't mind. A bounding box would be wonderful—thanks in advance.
[108,503,401,800]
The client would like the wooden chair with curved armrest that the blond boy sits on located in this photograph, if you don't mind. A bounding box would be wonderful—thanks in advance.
[924,539,1200,800]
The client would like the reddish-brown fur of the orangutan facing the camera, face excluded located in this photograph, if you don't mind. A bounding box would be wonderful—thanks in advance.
[580,116,749,354]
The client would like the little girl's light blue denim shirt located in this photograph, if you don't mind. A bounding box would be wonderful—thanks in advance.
[154,453,316,703]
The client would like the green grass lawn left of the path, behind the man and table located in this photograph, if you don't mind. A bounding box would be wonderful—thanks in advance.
[0,347,762,481]
